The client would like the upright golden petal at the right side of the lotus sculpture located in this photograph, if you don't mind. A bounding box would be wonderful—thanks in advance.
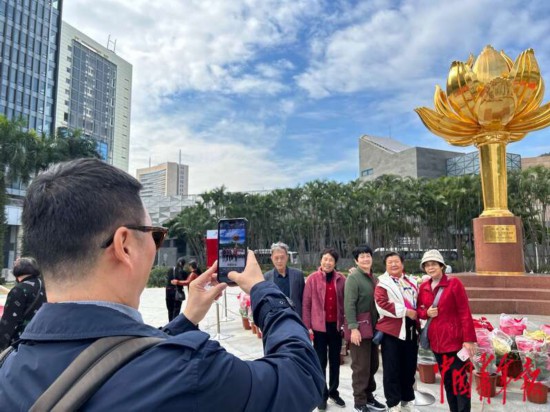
[509,49,544,116]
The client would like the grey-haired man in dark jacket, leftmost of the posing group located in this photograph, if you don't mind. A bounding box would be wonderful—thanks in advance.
[264,242,305,318]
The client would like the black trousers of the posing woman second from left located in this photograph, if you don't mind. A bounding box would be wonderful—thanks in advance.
[313,322,342,400]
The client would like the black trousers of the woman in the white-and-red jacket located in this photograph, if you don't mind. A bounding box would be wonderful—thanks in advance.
[382,322,418,408]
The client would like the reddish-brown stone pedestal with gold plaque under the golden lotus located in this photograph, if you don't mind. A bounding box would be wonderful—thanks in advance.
[473,216,525,275]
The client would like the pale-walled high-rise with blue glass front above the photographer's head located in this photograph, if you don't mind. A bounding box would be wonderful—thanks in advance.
[55,22,132,171]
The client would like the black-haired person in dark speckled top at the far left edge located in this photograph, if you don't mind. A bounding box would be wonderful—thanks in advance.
[0,257,46,350]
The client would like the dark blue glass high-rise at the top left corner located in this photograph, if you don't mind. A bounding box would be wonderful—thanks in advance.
[0,0,63,134]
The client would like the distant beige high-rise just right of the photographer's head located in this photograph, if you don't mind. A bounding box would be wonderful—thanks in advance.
[136,162,189,197]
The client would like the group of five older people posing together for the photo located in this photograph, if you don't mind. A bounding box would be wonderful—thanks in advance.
[264,242,476,412]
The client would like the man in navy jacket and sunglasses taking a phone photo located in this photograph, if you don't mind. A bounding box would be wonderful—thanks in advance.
[0,159,324,411]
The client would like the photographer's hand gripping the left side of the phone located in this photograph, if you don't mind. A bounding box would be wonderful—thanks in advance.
[183,262,227,325]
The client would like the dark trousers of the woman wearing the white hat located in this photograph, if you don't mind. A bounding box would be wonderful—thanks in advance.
[434,352,472,412]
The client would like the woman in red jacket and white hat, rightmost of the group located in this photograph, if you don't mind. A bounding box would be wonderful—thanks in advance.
[417,250,476,412]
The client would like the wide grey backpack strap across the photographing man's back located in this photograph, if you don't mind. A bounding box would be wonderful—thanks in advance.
[30,336,165,412]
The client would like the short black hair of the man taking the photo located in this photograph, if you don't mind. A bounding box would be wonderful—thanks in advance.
[22,159,145,280]
